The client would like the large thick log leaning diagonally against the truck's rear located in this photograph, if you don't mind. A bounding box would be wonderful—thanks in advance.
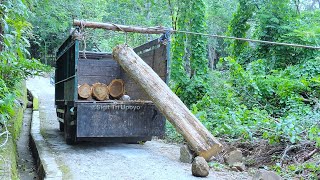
[113,45,222,160]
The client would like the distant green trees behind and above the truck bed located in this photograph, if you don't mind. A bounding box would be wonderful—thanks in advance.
[31,0,171,59]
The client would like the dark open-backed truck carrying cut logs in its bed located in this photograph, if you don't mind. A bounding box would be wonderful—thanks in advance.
[55,29,170,144]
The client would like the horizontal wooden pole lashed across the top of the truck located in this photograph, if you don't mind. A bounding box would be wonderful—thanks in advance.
[73,20,167,34]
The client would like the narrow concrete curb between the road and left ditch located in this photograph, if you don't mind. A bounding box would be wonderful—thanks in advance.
[30,91,62,180]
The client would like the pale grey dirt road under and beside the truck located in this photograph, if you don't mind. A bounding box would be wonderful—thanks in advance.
[27,77,248,180]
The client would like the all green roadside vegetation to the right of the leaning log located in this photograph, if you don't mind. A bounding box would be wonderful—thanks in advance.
[170,0,320,179]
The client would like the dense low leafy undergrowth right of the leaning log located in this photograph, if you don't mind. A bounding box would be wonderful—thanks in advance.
[193,58,320,146]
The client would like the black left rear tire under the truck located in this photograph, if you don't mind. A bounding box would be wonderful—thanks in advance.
[63,106,77,145]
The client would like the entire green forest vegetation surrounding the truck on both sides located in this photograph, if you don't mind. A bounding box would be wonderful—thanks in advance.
[0,0,320,179]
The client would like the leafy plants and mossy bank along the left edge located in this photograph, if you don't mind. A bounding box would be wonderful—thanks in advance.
[0,0,50,179]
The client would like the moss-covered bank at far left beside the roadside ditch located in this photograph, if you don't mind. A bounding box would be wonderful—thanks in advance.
[0,82,28,179]
